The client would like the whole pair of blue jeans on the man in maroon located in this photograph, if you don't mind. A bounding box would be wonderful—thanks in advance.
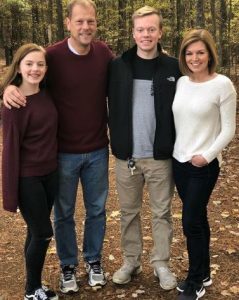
[54,147,109,266]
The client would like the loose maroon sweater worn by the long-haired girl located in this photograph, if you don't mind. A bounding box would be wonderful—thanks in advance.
[2,91,57,212]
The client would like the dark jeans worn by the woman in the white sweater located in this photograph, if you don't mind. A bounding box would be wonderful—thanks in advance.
[173,159,220,284]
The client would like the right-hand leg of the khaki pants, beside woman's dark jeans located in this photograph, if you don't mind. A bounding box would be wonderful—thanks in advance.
[141,158,174,266]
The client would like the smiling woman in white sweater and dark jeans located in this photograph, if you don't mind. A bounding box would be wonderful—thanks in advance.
[173,29,236,300]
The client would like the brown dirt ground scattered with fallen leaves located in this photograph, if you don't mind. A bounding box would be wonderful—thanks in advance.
[0,88,239,300]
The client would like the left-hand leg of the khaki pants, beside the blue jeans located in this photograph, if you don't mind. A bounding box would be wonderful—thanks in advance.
[115,159,144,266]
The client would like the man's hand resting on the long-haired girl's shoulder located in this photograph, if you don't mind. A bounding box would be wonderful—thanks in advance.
[3,85,26,109]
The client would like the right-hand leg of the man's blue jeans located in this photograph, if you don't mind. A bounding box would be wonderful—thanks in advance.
[80,147,109,262]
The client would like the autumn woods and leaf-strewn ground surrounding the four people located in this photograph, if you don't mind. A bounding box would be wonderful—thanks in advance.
[0,0,239,300]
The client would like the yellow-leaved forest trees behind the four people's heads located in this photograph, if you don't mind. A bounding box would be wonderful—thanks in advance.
[0,0,239,74]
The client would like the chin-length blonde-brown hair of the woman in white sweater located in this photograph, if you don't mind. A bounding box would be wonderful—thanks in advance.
[179,29,218,75]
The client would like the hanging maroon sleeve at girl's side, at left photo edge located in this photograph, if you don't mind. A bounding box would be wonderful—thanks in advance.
[2,108,20,212]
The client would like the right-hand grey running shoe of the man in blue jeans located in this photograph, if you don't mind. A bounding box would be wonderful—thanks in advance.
[86,261,106,286]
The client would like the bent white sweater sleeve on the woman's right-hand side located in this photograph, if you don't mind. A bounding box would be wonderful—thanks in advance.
[202,80,237,163]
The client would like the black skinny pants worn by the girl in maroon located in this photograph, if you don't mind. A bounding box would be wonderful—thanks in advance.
[19,172,58,293]
